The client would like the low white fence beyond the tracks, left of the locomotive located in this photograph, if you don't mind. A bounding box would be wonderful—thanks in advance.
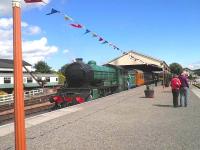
[0,89,44,103]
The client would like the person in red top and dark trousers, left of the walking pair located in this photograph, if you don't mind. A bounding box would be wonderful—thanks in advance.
[170,75,181,107]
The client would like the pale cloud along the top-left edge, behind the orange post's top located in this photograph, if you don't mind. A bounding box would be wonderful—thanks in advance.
[0,0,50,16]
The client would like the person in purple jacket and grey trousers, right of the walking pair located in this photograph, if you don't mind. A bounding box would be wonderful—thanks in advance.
[179,72,189,107]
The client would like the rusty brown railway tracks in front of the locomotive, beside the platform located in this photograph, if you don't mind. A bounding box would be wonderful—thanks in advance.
[0,94,54,125]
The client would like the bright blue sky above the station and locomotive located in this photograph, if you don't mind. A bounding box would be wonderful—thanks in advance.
[0,0,200,70]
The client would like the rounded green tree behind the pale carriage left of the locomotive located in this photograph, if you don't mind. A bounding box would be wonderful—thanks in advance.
[34,61,52,73]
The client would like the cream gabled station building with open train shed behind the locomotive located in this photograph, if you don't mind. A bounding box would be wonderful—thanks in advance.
[107,51,170,86]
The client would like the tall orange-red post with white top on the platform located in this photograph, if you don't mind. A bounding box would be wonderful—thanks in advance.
[12,0,26,150]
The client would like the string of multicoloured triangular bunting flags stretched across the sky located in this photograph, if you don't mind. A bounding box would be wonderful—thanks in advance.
[43,7,146,64]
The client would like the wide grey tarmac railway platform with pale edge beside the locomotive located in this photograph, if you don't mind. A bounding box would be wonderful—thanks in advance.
[0,86,200,150]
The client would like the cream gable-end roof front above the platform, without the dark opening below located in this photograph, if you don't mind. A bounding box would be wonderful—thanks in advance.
[105,50,169,70]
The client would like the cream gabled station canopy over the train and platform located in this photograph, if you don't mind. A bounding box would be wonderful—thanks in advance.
[107,51,170,72]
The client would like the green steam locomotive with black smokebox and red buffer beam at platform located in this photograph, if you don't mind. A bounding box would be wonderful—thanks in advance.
[50,59,155,109]
